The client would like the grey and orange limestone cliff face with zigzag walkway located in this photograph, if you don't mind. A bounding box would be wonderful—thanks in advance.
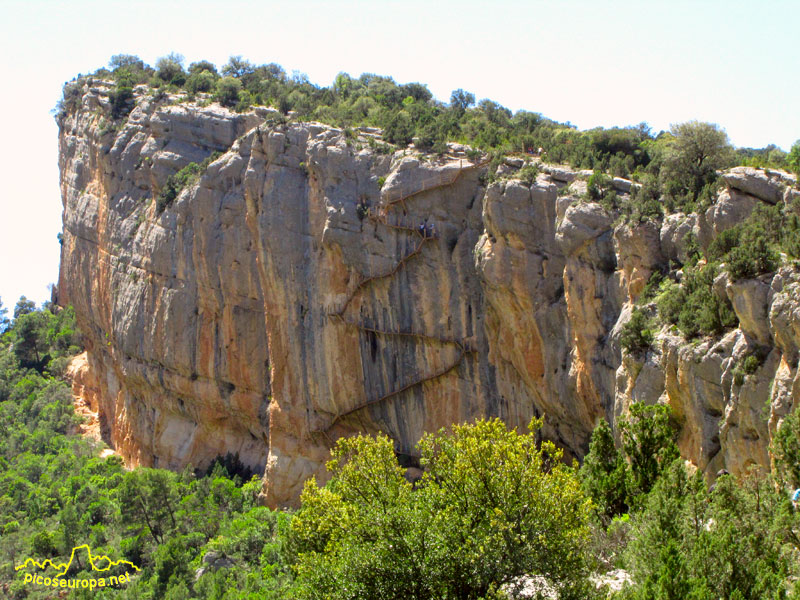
[58,81,800,505]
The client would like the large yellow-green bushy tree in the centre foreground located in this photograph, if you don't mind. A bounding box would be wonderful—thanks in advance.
[292,420,590,599]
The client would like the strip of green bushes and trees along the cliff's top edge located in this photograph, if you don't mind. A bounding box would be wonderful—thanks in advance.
[57,53,800,210]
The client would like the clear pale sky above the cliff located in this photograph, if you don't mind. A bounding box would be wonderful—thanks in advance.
[0,0,800,307]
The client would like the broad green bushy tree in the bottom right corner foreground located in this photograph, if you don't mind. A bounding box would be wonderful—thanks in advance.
[626,468,796,600]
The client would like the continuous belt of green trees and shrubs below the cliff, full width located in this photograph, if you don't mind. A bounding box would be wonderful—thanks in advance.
[0,298,800,600]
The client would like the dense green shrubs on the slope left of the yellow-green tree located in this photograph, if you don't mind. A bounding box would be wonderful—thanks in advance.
[0,308,291,600]
